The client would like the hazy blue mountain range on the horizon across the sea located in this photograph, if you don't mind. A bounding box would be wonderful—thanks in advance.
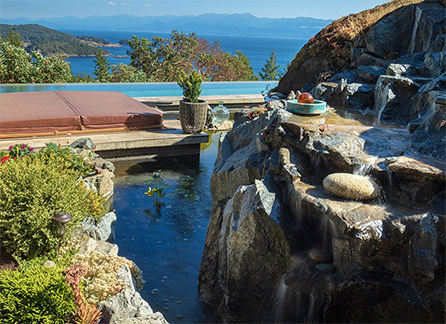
[2,14,331,38]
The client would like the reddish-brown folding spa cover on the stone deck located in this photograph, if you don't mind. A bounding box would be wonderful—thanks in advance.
[0,91,163,138]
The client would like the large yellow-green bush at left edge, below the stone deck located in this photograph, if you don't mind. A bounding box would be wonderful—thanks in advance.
[0,150,104,260]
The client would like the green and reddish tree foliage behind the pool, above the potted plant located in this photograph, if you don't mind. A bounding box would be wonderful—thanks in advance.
[127,30,257,82]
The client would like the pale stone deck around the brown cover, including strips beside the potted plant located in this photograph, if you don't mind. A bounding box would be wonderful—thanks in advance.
[0,95,264,162]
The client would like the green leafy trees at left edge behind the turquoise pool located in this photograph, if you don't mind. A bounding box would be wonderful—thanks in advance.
[0,41,72,83]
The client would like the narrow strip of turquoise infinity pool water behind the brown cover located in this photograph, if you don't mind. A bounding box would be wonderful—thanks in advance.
[0,81,278,97]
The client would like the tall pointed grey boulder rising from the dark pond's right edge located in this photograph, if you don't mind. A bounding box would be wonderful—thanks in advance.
[199,180,290,322]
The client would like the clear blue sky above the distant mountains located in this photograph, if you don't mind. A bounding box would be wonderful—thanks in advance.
[0,0,388,20]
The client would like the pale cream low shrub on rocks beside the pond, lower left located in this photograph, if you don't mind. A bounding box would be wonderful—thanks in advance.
[71,251,144,304]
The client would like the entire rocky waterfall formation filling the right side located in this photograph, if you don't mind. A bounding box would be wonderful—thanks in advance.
[200,1,446,323]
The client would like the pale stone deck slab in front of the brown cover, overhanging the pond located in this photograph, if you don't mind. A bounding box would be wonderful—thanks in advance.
[0,120,209,162]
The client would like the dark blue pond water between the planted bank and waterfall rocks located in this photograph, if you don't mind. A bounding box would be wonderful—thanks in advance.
[113,133,221,323]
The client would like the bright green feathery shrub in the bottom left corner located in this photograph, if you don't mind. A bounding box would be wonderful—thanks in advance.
[0,262,75,324]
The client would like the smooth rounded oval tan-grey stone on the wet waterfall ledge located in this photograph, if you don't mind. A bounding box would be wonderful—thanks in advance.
[323,173,381,200]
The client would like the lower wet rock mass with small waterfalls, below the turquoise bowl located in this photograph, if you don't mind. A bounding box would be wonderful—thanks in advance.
[199,109,446,322]
